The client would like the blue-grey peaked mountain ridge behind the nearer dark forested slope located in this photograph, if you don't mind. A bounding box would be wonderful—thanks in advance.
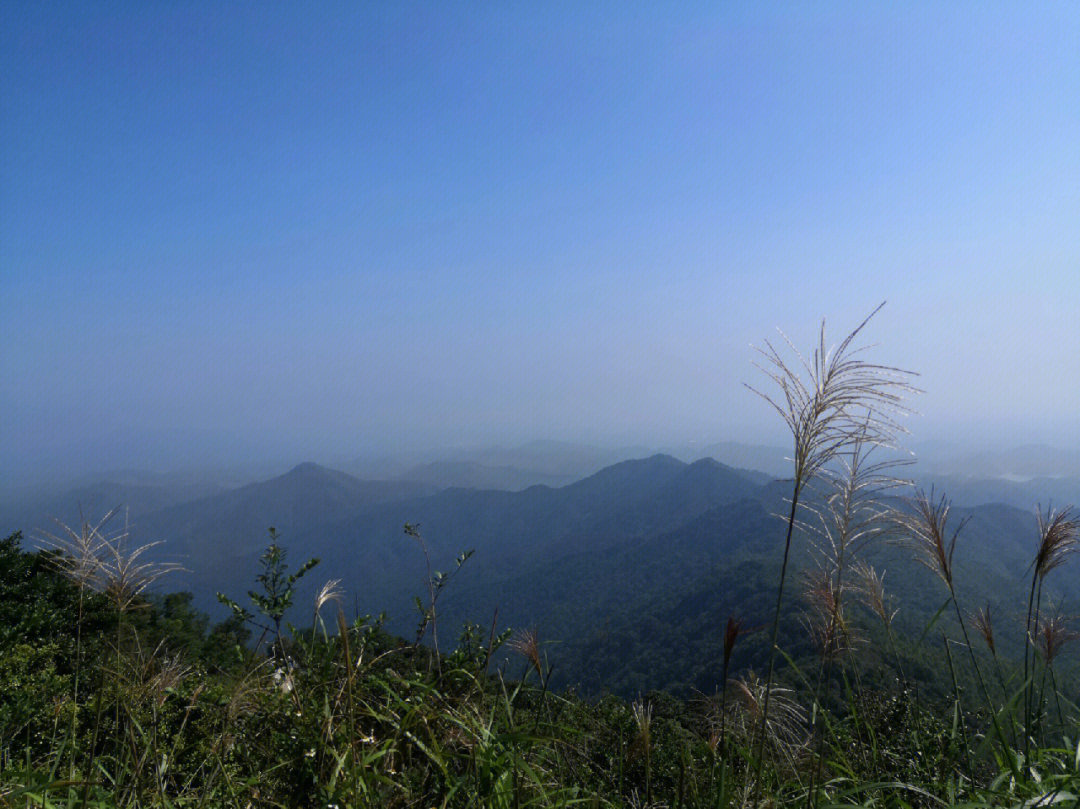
[73,455,759,626]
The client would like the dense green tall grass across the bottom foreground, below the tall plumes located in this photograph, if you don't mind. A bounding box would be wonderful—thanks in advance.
[0,501,1080,809]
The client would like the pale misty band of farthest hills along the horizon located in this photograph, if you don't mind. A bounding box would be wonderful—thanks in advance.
[0,440,1080,520]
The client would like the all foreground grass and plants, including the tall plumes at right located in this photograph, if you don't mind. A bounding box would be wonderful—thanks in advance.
[0,306,1080,809]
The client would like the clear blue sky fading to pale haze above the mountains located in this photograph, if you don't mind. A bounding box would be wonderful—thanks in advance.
[0,0,1080,481]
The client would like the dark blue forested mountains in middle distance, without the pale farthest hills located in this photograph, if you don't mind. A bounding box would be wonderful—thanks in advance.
[8,455,1080,693]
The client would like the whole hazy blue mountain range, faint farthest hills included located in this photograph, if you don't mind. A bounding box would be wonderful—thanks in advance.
[0,442,1080,693]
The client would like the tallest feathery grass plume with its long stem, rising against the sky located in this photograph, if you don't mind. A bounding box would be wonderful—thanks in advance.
[746,302,917,784]
